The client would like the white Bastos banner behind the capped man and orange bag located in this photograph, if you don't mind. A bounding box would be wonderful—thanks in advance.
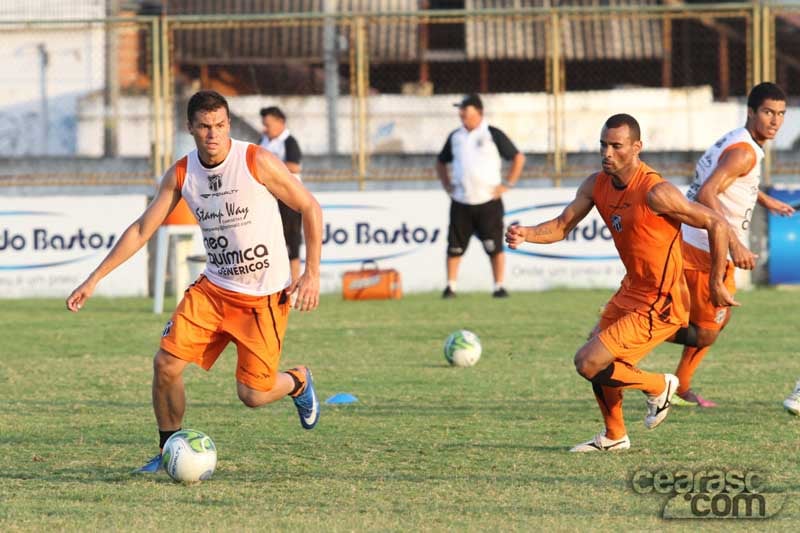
[315,188,624,292]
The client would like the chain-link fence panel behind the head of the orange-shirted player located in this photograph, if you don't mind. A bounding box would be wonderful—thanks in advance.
[558,6,753,182]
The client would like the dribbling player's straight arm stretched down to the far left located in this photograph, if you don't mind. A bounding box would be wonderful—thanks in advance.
[66,166,181,312]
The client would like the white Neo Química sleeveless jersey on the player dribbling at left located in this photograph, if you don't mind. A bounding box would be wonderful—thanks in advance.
[178,139,291,296]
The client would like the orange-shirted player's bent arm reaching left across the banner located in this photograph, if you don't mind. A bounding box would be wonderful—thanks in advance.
[506,174,597,249]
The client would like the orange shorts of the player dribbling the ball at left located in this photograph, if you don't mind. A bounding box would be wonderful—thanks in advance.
[161,276,289,391]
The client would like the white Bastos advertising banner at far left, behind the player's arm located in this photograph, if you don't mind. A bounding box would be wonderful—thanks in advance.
[0,195,147,298]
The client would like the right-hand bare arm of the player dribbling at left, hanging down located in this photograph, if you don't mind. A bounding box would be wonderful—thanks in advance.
[256,147,322,311]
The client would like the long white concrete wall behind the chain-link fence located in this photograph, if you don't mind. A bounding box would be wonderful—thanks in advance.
[6,84,800,157]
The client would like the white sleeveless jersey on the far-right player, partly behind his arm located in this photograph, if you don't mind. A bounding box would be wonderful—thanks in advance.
[683,128,764,252]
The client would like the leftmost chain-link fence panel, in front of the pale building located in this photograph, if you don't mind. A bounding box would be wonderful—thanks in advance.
[0,11,162,185]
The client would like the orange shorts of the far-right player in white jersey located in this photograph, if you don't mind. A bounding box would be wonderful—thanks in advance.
[681,243,736,331]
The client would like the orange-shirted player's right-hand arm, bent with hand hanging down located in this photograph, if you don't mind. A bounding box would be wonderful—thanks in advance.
[647,181,739,307]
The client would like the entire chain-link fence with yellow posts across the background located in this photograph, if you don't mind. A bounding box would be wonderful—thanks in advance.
[6,0,800,187]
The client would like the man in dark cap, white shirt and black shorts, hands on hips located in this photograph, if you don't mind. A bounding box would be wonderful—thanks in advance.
[436,94,525,298]
